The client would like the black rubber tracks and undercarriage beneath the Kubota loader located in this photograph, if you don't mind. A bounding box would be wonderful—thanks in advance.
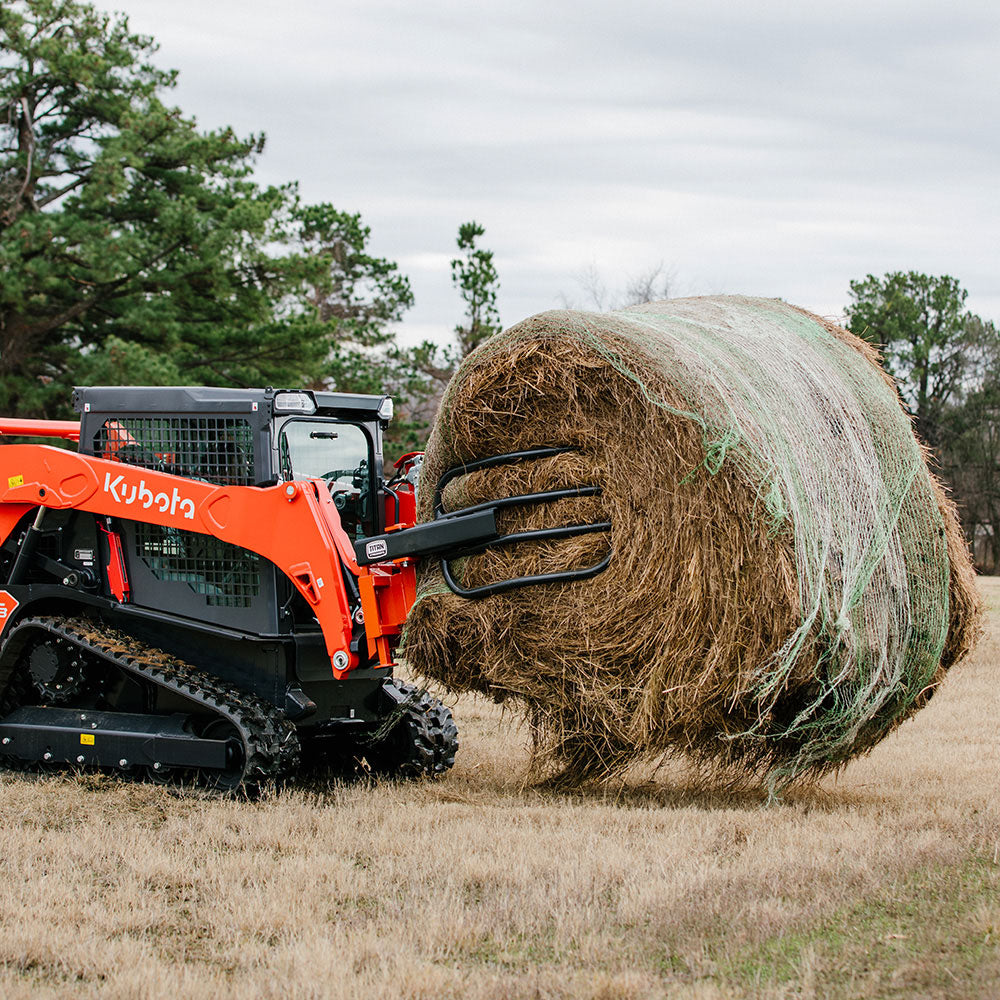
[0,616,458,793]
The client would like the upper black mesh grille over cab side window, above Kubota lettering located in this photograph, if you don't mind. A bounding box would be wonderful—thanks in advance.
[94,417,256,486]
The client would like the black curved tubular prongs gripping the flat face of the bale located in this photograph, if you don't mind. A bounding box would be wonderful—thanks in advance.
[434,447,614,599]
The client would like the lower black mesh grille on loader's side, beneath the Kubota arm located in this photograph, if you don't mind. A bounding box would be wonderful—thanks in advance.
[135,522,261,608]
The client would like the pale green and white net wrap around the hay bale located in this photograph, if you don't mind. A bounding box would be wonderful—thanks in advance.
[586,300,949,766]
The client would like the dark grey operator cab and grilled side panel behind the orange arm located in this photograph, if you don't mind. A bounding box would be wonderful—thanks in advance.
[73,386,392,636]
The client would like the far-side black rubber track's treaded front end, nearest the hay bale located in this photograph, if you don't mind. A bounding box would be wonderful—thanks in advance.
[365,681,458,778]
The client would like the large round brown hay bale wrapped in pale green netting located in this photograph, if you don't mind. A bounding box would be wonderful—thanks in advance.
[405,297,978,788]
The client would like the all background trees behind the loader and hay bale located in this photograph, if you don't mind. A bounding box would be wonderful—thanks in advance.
[0,0,1000,569]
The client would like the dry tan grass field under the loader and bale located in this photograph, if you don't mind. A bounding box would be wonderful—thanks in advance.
[0,580,1000,1000]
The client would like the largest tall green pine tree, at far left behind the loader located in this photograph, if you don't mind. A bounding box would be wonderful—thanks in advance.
[0,0,325,415]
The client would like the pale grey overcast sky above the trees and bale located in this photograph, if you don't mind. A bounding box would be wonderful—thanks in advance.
[98,0,1000,341]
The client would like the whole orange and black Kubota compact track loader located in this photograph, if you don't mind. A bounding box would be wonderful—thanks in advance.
[0,387,512,790]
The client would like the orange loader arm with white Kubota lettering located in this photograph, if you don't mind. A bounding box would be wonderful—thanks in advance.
[0,444,386,679]
